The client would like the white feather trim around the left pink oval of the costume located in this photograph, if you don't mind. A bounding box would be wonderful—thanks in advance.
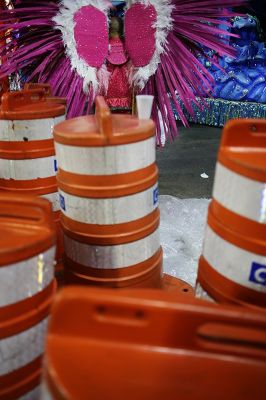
[53,0,110,93]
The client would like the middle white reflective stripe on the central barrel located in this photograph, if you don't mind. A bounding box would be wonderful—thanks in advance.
[59,184,158,225]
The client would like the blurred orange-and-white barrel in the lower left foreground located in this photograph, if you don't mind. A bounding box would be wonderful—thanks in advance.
[0,193,56,400]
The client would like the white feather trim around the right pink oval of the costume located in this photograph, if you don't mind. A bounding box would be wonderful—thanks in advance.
[128,0,173,90]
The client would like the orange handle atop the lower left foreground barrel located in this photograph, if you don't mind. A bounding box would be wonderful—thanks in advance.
[0,193,52,227]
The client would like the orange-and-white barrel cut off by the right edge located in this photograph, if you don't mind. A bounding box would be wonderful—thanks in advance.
[196,120,266,307]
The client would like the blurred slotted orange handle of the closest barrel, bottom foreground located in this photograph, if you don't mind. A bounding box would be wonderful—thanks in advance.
[50,286,266,358]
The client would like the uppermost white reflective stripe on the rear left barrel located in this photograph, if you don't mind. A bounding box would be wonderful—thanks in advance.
[0,115,65,142]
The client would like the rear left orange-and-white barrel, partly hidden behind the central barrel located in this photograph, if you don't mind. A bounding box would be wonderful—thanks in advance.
[0,89,65,272]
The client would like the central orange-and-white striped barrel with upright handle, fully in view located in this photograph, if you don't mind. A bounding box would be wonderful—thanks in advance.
[54,97,162,287]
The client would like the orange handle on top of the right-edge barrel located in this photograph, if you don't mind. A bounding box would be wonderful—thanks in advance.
[221,119,266,148]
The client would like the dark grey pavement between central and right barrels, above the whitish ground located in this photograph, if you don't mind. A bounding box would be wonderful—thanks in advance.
[157,125,221,199]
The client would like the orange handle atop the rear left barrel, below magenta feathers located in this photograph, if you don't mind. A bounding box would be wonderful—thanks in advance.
[1,89,45,112]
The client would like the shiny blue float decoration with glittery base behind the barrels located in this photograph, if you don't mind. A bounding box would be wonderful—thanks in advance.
[176,15,266,126]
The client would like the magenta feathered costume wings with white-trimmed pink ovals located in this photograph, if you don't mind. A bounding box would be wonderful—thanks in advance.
[0,0,243,143]
